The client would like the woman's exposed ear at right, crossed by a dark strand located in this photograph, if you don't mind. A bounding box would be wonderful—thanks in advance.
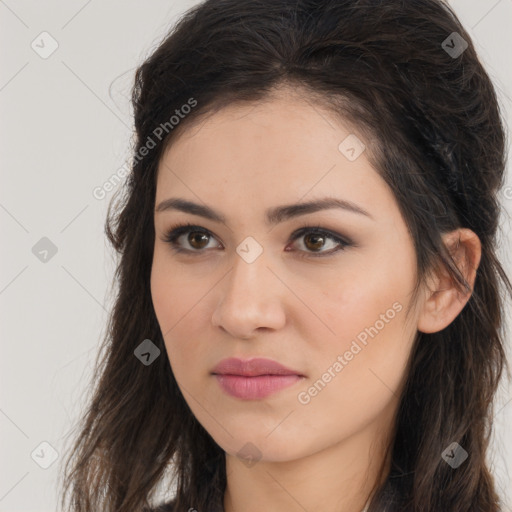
[418,228,482,333]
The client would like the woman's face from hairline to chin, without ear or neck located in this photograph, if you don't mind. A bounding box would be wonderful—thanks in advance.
[151,90,424,461]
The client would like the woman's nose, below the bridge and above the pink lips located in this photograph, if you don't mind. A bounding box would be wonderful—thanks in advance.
[212,252,289,339]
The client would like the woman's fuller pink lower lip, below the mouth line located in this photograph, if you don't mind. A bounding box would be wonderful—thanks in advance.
[215,374,303,400]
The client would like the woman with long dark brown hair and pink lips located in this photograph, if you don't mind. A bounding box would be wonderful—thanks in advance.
[58,0,512,512]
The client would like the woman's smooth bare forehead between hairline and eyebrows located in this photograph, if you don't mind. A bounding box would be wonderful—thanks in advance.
[157,94,394,224]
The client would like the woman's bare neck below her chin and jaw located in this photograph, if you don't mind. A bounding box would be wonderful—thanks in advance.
[224,425,390,512]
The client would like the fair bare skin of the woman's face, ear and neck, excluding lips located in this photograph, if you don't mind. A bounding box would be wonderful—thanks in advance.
[151,91,480,512]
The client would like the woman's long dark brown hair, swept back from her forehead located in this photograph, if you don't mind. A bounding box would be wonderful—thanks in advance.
[58,0,512,512]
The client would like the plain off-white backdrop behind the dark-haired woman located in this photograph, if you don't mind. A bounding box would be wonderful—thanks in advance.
[0,0,512,512]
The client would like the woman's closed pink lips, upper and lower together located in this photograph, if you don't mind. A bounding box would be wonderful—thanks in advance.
[212,357,305,400]
